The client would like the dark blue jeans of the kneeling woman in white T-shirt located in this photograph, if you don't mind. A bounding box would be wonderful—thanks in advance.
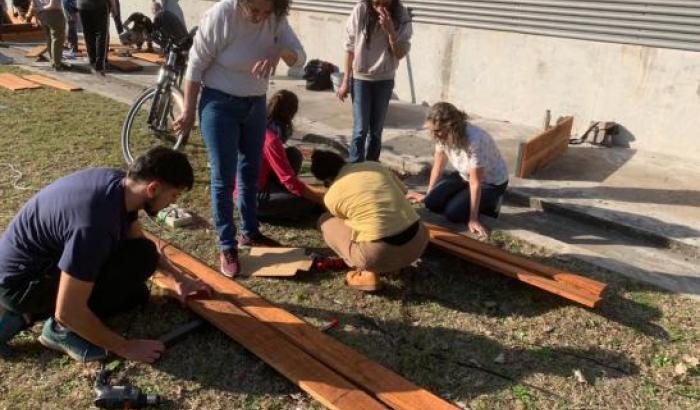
[424,172,508,223]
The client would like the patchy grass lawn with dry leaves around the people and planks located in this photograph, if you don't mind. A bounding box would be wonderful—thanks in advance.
[0,67,700,409]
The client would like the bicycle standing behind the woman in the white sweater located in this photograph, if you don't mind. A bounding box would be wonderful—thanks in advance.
[121,16,197,164]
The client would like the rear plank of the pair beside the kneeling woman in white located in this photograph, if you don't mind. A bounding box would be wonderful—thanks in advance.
[425,224,608,296]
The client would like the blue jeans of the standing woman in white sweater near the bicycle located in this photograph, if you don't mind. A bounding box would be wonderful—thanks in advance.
[199,87,266,250]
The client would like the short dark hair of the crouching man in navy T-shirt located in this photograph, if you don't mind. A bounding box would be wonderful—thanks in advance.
[126,147,194,190]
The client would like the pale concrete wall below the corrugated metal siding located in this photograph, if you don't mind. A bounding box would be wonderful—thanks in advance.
[116,0,700,158]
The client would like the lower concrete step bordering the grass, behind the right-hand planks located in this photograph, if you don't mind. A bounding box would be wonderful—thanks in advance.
[421,205,700,301]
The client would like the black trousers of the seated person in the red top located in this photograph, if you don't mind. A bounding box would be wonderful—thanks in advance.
[258,147,323,221]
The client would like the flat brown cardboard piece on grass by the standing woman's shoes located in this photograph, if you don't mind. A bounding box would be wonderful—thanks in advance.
[241,248,313,277]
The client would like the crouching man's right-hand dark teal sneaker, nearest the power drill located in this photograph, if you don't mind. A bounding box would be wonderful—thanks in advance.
[39,318,108,363]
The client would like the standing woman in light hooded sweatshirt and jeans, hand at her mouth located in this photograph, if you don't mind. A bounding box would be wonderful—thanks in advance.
[338,0,413,162]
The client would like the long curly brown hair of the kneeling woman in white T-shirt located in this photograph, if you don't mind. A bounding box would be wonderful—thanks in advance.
[426,102,469,150]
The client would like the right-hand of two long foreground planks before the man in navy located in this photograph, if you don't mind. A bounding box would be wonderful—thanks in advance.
[147,234,457,410]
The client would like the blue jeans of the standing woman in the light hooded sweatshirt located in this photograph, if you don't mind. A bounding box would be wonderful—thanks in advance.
[350,79,394,162]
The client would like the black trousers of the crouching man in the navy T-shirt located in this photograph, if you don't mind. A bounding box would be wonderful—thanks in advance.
[0,238,159,320]
